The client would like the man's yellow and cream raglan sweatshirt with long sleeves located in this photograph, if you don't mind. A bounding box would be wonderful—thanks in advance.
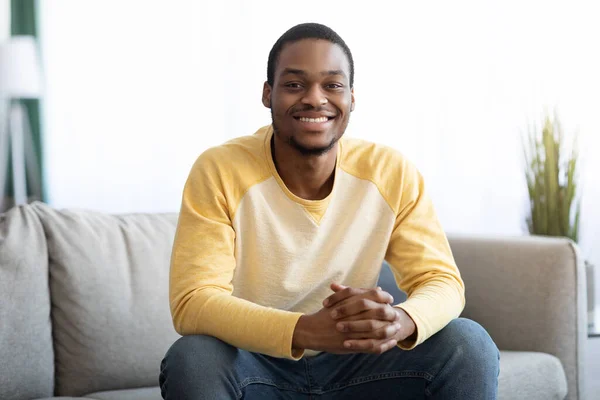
[170,126,465,359]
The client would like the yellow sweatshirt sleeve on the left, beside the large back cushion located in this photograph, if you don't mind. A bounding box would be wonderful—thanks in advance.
[169,150,303,359]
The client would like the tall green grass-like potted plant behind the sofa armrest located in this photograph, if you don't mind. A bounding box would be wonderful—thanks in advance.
[523,115,594,324]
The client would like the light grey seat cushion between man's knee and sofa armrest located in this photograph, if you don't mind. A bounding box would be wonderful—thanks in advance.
[498,351,567,400]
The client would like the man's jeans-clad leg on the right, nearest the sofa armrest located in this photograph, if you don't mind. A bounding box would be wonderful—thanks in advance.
[307,318,499,400]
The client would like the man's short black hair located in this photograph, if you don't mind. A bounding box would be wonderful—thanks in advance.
[267,23,354,87]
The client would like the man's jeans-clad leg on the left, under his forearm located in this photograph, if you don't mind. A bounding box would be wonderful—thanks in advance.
[159,335,309,400]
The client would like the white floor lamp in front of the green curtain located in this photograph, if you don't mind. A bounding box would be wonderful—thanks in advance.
[0,36,41,211]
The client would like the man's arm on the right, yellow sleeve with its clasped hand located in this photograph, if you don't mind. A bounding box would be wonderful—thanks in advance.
[324,158,465,351]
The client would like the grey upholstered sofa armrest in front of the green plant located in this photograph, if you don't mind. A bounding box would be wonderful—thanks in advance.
[449,236,587,399]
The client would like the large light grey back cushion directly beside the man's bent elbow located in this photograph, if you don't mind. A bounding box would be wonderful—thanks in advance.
[36,203,178,396]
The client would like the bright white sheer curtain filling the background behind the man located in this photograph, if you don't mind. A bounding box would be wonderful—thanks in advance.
[40,0,600,294]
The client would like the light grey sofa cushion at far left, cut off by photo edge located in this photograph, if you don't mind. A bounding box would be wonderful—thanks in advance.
[0,206,54,400]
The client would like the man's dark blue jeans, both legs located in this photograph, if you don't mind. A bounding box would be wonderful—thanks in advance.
[160,318,500,400]
